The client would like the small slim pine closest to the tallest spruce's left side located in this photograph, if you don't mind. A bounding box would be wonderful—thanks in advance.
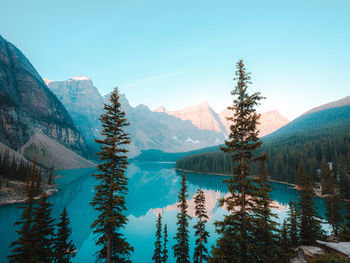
[193,189,209,263]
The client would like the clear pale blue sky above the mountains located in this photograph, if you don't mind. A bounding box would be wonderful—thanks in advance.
[0,0,350,119]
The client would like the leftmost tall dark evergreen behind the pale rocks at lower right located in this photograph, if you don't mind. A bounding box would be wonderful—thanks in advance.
[298,162,324,245]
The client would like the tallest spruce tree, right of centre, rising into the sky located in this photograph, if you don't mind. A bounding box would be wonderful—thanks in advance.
[210,60,263,263]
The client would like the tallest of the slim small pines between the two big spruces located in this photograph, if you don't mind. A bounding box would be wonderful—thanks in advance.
[173,173,190,263]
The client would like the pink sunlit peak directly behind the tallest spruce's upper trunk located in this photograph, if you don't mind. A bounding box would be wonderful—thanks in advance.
[219,109,289,137]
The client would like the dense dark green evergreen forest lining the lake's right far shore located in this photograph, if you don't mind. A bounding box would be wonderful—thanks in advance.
[176,130,350,192]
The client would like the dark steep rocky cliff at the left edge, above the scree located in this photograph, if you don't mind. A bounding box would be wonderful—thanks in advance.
[0,36,85,153]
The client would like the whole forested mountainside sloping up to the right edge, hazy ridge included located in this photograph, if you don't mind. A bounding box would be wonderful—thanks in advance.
[176,97,350,185]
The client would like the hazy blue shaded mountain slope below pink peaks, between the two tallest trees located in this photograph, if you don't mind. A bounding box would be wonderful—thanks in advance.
[115,95,224,156]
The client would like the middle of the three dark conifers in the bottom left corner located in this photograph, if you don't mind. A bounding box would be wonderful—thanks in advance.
[32,193,54,262]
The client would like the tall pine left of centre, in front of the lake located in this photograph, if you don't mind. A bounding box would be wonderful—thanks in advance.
[91,88,134,263]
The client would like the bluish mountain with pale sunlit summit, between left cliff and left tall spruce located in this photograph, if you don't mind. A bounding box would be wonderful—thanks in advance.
[45,76,103,144]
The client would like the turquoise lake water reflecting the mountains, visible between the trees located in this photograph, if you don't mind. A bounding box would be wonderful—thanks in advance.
[0,163,325,263]
